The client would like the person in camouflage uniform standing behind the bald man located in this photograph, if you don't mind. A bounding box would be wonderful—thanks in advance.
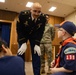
[40,15,55,73]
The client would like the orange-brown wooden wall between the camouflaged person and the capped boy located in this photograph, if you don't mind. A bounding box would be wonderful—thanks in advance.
[49,16,64,59]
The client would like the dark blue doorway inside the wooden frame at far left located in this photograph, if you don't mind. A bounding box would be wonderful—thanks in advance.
[0,22,11,47]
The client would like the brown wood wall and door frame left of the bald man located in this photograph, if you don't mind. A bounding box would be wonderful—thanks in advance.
[0,10,18,54]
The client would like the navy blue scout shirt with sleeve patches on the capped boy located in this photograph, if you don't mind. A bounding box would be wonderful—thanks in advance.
[52,38,76,75]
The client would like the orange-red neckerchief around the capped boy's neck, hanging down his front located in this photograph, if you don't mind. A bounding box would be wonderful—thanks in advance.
[55,38,76,67]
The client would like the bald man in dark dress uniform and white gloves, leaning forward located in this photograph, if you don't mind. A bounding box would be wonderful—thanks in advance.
[17,3,46,75]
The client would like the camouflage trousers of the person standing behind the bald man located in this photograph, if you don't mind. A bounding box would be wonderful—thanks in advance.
[40,43,53,67]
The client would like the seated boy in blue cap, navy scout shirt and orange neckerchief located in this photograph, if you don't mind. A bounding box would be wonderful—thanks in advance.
[50,21,76,75]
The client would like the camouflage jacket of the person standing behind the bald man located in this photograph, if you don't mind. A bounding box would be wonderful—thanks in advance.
[41,24,55,44]
